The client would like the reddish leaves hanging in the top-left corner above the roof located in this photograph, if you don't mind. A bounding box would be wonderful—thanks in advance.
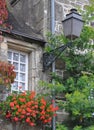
[0,0,8,25]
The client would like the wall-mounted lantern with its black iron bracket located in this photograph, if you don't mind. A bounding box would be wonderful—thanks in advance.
[43,9,84,71]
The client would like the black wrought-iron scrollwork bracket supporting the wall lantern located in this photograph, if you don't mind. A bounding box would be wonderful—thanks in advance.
[43,43,71,71]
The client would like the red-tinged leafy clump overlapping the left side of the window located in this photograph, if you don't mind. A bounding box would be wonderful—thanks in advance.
[0,61,16,86]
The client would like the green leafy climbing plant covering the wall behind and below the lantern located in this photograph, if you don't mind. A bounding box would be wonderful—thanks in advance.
[43,0,94,130]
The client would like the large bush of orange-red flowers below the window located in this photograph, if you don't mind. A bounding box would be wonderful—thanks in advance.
[0,92,58,126]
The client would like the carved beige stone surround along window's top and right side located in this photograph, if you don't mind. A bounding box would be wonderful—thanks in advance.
[4,37,42,91]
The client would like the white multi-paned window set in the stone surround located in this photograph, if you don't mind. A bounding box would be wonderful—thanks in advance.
[8,50,28,91]
